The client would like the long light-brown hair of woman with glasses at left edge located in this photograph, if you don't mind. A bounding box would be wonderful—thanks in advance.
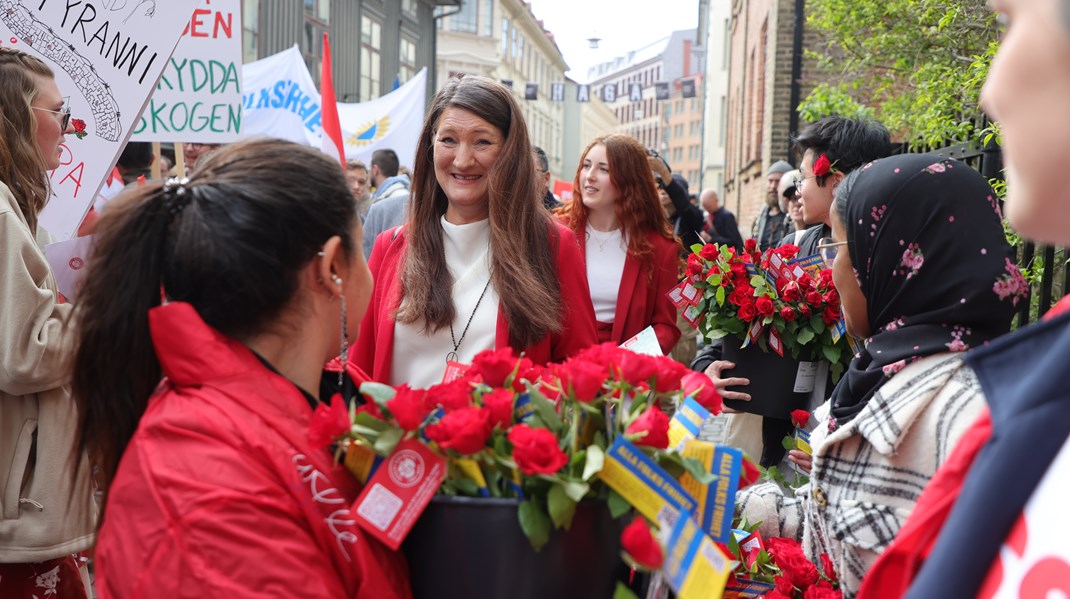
[0,48,55,233]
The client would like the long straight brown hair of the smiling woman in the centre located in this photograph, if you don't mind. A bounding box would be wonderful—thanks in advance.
[400,76,562,351]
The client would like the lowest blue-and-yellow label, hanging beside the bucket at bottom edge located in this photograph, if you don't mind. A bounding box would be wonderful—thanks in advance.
[662,509,733,599]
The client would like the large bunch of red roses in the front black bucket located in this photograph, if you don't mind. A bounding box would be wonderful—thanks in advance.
[309,344,721,549]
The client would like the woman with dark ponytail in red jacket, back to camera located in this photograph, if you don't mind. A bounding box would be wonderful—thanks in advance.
[66,139,410,599]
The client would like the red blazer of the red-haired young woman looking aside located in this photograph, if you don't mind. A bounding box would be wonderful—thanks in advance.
[580,226,681,355]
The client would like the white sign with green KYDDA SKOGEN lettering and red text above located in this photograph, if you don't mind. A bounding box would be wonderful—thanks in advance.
[131,0,242,143]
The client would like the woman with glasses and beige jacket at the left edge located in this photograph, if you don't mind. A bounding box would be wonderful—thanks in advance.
[0,48,94,598]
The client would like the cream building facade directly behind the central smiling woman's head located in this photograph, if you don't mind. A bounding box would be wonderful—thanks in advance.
[434,0,574,181]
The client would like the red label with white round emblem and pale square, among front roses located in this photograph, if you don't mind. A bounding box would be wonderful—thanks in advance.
[353,439,446,550]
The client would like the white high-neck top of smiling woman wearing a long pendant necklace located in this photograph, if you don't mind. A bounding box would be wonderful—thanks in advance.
[389,217,499,389]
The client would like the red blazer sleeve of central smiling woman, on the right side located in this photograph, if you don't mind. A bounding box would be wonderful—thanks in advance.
[550,225,598,362]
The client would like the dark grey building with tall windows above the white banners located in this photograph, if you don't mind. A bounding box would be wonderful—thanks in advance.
[242,0,442,102]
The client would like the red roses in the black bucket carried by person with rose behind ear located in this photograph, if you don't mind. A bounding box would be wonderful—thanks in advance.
[681,240,851,378]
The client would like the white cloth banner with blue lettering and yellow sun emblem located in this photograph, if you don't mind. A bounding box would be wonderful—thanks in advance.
[242,46,427,168]
